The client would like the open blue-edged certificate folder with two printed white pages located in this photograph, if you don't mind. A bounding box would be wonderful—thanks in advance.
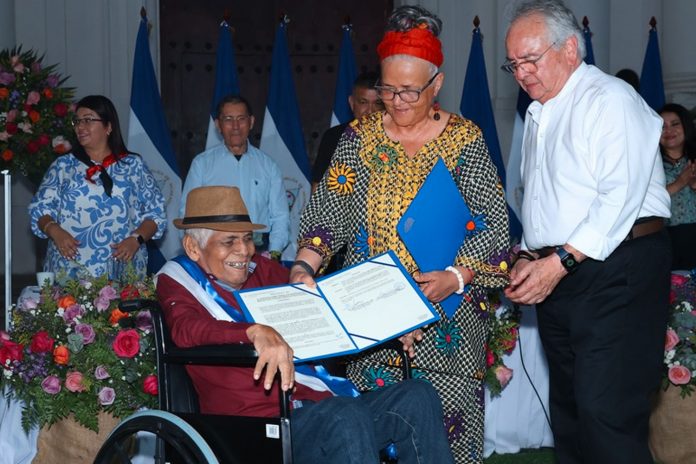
[235,251,439,362]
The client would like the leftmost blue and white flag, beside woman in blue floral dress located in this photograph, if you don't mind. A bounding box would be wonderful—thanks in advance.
[128,12,181,272]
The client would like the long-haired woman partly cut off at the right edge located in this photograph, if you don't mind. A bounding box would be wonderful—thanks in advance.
[660,103,696,270]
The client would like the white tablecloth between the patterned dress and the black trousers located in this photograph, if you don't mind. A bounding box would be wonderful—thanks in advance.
[483,306,553,457]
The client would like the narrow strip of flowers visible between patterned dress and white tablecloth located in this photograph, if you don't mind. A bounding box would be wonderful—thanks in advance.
[484,295,520,396]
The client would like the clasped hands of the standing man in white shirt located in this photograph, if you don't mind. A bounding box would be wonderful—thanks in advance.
[505,254,568,305]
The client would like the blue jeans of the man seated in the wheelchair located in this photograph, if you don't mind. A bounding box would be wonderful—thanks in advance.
[291,380,454,464]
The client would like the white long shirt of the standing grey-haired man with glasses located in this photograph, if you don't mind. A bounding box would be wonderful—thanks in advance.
[521,62,670,260]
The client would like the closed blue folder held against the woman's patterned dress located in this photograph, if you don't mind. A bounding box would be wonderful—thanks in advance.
[396,158,472,318]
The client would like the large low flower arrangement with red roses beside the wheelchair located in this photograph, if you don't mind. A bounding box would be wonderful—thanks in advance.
[0,273,157,431]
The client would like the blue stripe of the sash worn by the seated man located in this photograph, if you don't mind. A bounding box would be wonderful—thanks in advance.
[172,255,360,397]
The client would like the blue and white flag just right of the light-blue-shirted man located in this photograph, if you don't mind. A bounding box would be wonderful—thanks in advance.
[260,20,310,261]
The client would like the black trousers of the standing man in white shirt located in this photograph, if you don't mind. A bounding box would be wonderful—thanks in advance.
[537,230,671,464]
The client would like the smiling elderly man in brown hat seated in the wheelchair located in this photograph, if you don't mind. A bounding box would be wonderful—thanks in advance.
[99,187,453,464]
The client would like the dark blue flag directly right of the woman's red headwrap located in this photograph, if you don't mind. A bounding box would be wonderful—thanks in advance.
[459,25,522,238]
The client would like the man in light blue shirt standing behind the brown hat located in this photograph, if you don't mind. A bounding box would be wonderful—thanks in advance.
[180,95,290,259]
